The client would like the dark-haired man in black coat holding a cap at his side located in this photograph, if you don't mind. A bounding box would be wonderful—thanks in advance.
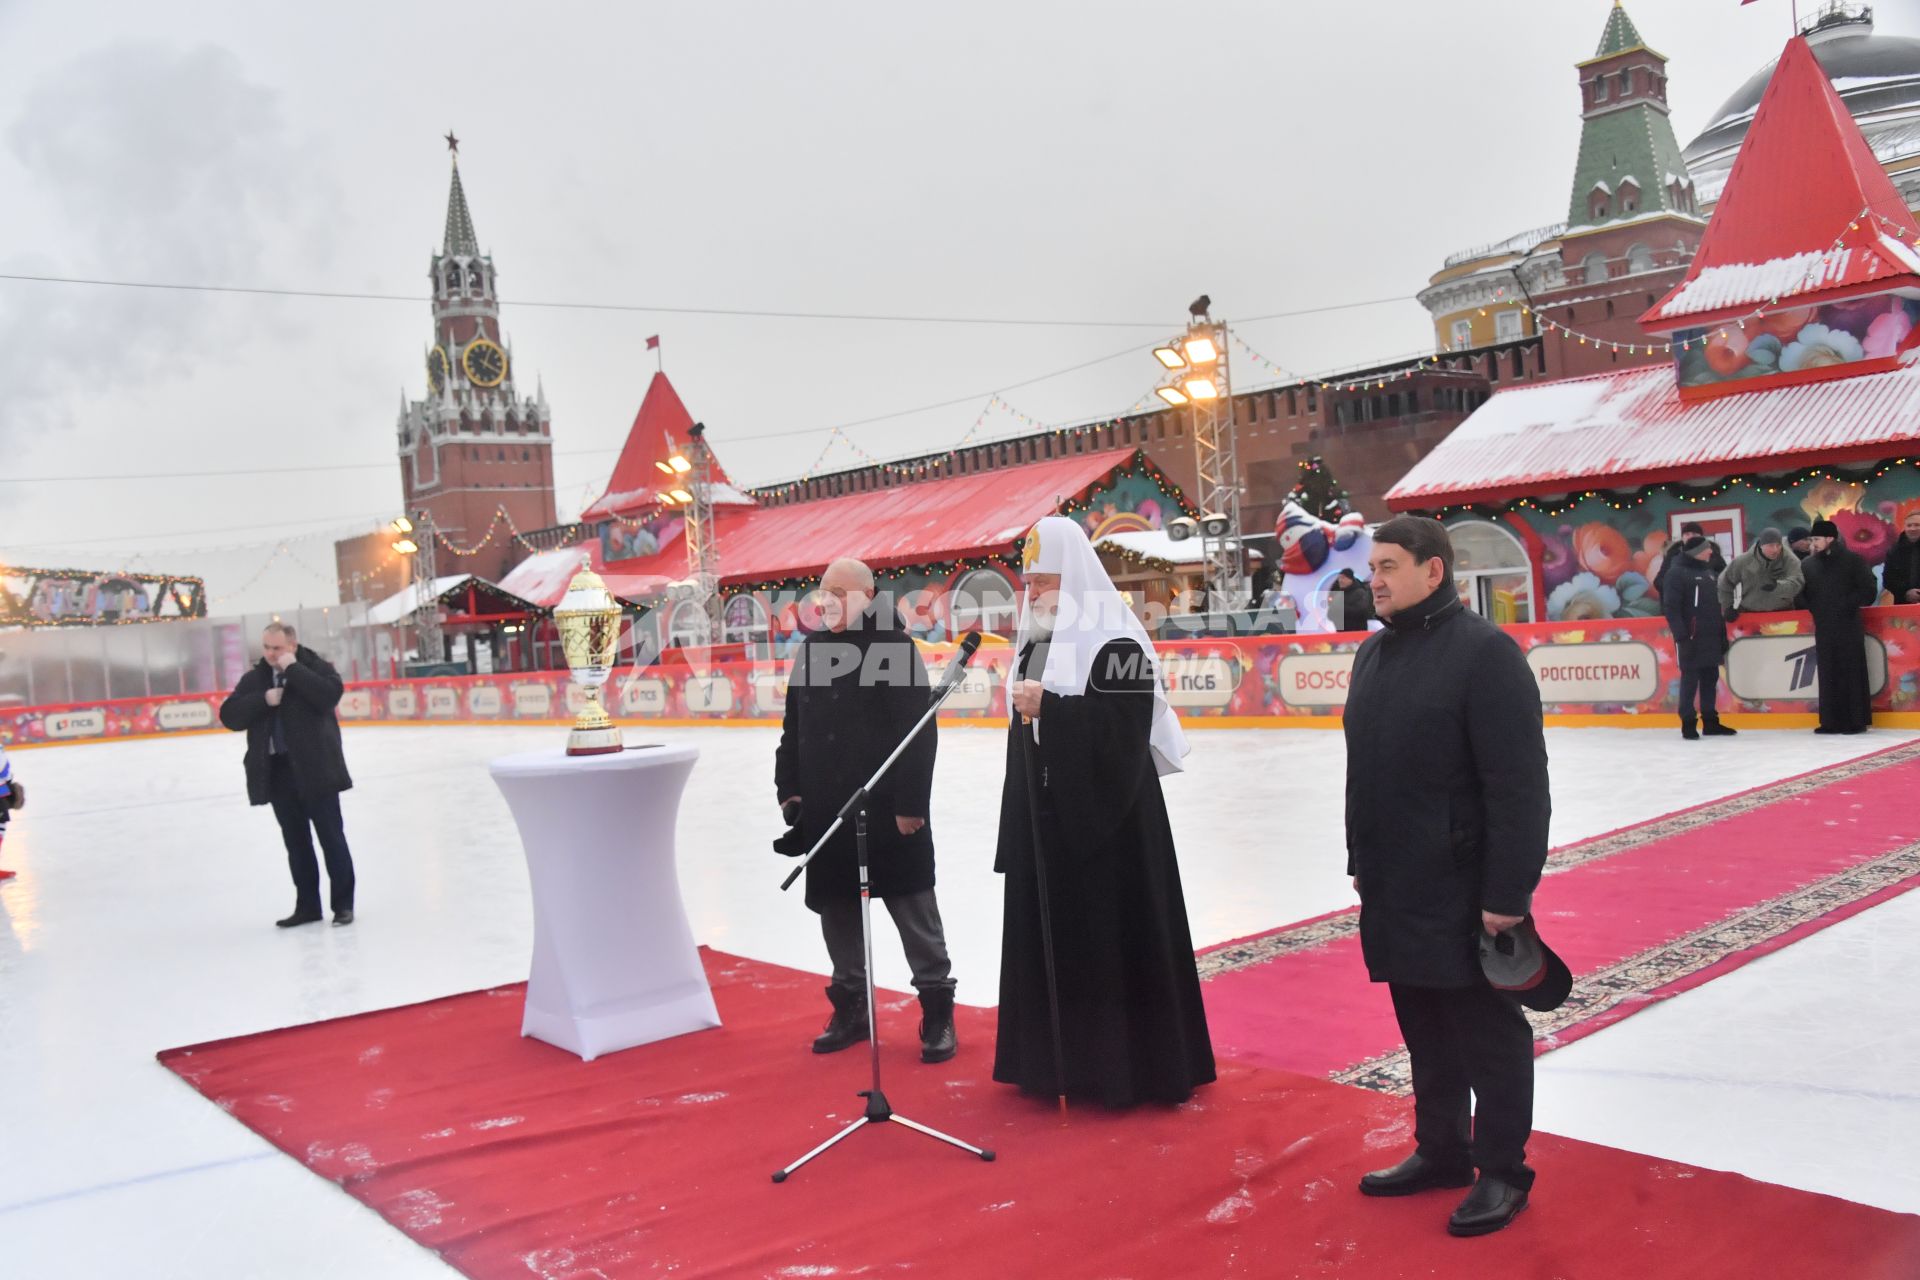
[1346,516,1551,1236]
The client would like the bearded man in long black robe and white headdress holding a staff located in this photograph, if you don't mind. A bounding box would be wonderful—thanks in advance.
[993,516,1213,1107]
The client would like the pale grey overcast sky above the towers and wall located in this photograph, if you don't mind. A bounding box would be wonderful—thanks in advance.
[0,0,1920,612]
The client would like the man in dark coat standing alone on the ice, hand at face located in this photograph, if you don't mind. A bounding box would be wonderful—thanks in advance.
[221,622,353,929]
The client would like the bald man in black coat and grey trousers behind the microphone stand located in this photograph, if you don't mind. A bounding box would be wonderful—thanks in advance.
[774,560,958,1063]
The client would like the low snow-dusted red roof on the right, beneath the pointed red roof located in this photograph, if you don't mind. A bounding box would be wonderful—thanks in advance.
[1386,363,1920,510]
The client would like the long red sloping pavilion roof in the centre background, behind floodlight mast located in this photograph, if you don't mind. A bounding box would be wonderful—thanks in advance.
[602,449,1139,583]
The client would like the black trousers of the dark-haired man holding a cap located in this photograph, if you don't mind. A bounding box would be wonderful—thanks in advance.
[1388,983,1534,1188]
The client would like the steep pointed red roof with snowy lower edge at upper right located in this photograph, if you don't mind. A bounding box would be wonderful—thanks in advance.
[1640,36,1920,332]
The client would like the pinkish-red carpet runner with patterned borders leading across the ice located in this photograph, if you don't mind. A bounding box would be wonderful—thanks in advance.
[1202,745,1920,1090]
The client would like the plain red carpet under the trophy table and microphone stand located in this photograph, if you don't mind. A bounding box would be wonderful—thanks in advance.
[161,954,1920,1280]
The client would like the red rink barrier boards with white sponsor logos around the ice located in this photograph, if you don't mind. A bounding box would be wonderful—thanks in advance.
[0,604,1920,748]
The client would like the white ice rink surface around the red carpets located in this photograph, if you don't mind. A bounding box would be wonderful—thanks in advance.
[0,727,1920,1280]
